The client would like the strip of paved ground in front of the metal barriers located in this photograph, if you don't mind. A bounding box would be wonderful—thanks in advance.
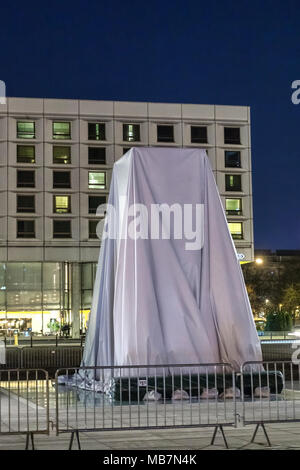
[0,423,300,450]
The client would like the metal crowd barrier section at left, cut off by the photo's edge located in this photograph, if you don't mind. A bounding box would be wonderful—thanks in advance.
[0,369,49,450]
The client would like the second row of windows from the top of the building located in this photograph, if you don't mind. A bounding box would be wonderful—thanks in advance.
[17,145,241,168]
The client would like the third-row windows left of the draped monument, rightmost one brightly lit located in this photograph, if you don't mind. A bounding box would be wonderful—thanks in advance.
[17,170,107,189]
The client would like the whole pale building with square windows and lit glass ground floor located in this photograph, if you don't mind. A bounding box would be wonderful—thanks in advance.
[0,98,253,337]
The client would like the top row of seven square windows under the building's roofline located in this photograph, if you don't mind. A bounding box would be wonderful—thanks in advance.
[17,121,241,145]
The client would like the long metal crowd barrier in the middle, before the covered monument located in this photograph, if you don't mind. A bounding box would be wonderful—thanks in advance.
[55,363,236,449]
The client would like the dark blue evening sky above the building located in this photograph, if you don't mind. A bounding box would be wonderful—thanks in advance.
[0,0,300,249]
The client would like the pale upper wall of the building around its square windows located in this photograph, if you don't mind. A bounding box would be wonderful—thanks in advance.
[0,98,253,334]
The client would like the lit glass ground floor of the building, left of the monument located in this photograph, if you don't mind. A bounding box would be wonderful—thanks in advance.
[0,262,97,337]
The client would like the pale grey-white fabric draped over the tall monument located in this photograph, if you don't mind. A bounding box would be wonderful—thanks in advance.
[82,147,262,370]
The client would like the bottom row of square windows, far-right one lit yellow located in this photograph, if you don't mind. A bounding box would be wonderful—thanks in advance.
[17,220,243,240]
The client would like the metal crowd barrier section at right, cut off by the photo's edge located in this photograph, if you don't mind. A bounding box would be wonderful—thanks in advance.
[241,361,300,446]
